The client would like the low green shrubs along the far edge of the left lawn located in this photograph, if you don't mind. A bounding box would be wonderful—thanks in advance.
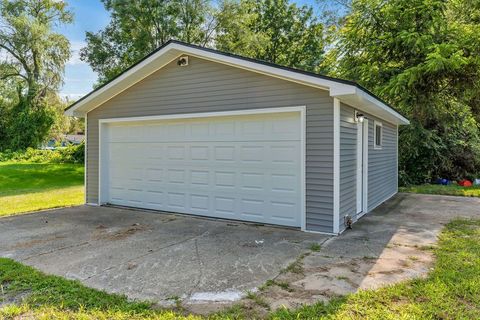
[0,143,85,163]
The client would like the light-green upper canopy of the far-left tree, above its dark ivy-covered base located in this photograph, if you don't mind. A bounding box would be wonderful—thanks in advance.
[0,0,72,106]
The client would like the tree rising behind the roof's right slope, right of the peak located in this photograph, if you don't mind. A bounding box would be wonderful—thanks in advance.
[215,0,325,71]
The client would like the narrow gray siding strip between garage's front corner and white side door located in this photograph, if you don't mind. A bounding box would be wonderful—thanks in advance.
[339,103,357,232]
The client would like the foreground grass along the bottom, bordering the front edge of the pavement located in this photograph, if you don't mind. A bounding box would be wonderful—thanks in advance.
[0,220,480,320]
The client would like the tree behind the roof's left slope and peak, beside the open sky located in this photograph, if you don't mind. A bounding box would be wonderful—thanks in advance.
[81,0,215,83]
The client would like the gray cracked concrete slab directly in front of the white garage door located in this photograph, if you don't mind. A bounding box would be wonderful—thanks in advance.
[0,206,327,304]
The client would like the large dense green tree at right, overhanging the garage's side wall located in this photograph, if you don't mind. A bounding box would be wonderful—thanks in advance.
[325,0,480,183]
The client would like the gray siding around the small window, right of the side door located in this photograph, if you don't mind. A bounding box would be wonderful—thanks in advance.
[368,115,398,211]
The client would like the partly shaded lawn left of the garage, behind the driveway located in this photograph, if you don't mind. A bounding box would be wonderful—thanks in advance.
[0,162,84,216]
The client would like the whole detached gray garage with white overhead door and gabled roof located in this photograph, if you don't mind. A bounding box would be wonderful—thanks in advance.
[66,41,408,234]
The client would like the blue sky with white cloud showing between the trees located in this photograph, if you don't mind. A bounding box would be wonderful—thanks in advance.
[57,0,326,100]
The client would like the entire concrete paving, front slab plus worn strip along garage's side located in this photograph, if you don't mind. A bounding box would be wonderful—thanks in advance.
[0,194,480,312]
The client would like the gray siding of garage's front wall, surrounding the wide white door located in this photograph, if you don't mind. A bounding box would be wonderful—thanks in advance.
[86,57,333,233]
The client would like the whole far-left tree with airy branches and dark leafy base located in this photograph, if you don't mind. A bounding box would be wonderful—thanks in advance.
[0,0,72,149]
